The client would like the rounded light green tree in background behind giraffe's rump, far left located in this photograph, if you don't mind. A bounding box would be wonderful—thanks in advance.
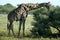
[0,3,15,13]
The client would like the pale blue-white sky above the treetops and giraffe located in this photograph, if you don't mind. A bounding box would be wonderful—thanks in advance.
[0,0,60,6]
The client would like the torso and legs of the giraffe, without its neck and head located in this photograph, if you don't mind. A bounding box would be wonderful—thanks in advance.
[7,6,28,36]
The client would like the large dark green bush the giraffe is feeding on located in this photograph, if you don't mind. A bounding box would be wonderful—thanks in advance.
[31,6,60,35]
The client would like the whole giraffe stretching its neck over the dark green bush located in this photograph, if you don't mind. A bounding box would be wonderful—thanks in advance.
[7,2,50,36]
